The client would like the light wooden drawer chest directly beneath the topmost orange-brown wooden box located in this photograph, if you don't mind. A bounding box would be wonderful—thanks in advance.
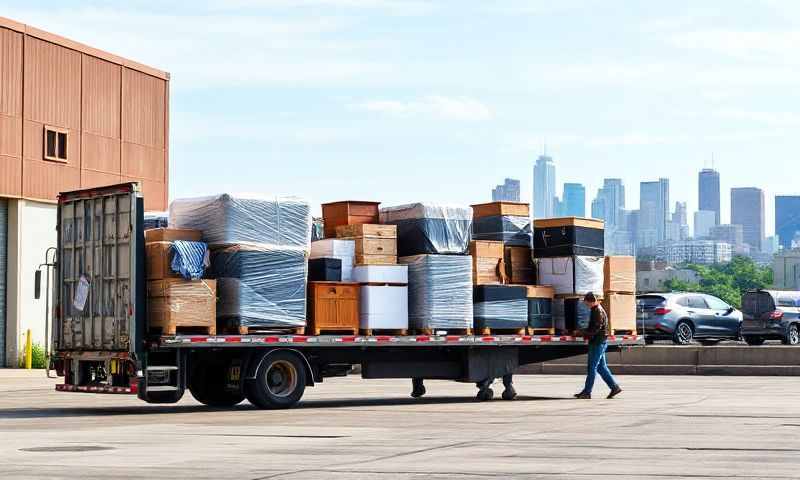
[336,224,397,265]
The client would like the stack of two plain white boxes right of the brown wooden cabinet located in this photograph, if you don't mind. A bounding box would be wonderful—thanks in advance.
[353,265,408,335]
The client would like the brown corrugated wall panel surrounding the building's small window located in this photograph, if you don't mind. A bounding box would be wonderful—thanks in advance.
[22,36,81,200]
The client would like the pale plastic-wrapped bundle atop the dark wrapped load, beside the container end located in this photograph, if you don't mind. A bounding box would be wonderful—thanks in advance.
[169,193,311,252]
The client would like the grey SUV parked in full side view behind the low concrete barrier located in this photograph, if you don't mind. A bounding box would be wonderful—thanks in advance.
[636,293,742,345]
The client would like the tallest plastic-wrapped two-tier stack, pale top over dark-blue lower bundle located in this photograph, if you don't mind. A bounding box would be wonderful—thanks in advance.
[169,194,312,334]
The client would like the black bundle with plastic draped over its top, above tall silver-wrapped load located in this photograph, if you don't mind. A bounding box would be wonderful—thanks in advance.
[380,203,472,257]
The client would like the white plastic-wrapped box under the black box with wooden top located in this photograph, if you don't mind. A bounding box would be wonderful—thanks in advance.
[535,256,604,295]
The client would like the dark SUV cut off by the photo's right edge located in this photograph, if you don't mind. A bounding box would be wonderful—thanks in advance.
[742,290,800,345]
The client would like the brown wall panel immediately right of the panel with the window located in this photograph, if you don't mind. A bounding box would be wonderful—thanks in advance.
[81,55,122,178]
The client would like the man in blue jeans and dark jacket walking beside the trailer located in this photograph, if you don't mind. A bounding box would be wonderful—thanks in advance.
[575,292,622,399]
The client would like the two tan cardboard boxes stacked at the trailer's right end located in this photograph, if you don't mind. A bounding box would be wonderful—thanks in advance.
[603,256,636,334]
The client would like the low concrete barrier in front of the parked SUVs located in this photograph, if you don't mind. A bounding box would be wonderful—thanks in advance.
[519,345,800,376]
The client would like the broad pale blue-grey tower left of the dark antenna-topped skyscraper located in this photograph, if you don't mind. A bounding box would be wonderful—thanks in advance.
[637,178,669,248]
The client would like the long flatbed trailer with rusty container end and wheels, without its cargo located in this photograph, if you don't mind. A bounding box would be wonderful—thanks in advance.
[53,183,643,408]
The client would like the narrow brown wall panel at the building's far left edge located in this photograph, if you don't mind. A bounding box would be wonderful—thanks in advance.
[0,28,22,197]
